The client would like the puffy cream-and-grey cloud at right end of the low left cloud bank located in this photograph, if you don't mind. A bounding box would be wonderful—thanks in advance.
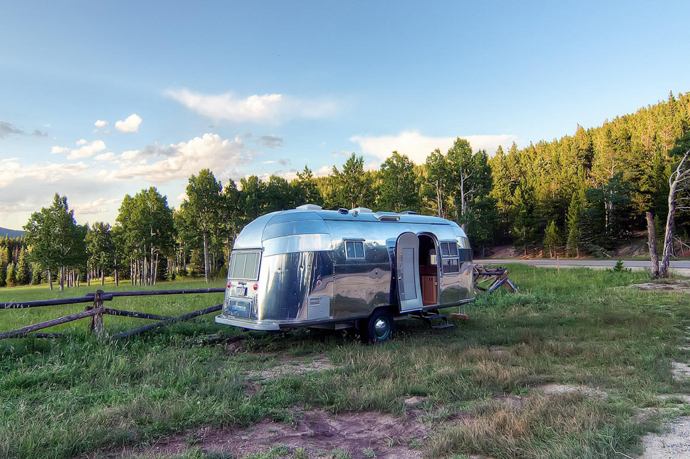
[111,133,253,183]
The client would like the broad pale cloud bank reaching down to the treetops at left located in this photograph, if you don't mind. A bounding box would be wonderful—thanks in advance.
[0,133,255,228]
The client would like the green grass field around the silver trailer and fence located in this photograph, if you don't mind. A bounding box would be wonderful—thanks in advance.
[0,266,690,458]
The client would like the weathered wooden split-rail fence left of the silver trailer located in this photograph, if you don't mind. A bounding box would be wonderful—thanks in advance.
[0,288,225,340]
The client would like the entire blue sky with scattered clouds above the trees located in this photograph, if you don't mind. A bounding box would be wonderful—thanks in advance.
[0,1,690,228]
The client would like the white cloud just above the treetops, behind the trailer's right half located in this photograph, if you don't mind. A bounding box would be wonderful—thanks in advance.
[350,131,517,164]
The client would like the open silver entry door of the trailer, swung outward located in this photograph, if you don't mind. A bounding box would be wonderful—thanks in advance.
[395,233,422,312]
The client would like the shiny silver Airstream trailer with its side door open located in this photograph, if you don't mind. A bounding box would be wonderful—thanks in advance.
[215,204,474,342]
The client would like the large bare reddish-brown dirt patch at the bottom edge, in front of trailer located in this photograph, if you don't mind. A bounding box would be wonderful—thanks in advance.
[110,410,428,459]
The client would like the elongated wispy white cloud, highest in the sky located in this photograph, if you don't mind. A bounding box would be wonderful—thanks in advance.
[165,88,338,123]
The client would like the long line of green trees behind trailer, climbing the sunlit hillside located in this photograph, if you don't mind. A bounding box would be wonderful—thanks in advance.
[0,93,690,288]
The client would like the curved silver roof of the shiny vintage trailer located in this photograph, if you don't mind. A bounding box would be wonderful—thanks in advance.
[234,205,464,249]
